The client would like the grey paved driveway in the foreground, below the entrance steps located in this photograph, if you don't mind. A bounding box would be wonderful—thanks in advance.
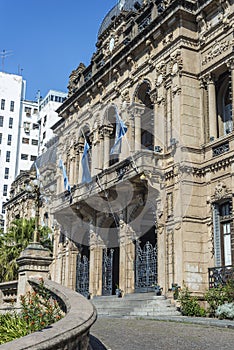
[91,316,234,350]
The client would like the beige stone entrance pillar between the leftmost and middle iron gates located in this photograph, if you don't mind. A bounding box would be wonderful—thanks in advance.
[89,230,104,298]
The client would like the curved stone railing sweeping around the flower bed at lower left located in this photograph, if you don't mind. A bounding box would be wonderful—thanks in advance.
[0,278,97,350]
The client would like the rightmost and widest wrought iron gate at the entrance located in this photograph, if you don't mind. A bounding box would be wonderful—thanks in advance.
[135,241,157,292]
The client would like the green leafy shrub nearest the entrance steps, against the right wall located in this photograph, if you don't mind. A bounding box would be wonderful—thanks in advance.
[178,287,206,317]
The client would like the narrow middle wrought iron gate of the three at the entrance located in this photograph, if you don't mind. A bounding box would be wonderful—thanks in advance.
[102,249,114,295]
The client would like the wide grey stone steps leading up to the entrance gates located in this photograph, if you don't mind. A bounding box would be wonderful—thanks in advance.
[91,293,181,318]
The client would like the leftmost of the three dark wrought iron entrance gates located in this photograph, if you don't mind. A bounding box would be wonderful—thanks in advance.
[76,254,89,298]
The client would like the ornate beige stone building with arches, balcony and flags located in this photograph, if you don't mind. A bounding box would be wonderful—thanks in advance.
[3,0,234,296]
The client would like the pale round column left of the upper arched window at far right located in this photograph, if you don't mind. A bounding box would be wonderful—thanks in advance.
[207,74,217,141]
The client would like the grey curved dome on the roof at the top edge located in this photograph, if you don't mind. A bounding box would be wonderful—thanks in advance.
[98,0,144,37]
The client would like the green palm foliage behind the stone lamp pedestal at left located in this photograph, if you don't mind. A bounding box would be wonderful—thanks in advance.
[0,218,52,283]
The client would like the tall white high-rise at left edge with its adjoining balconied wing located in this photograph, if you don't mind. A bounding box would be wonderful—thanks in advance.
[0,72,39,228]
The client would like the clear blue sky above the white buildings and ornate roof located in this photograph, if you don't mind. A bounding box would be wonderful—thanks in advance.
[0,0,118,100]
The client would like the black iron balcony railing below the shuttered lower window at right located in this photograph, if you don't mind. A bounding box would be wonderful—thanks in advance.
[208,266,234,289]
